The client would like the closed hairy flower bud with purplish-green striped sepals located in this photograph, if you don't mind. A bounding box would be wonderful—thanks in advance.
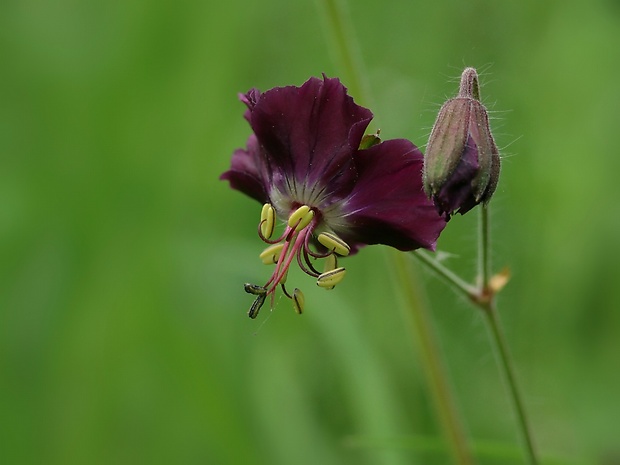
[423,68,500,219]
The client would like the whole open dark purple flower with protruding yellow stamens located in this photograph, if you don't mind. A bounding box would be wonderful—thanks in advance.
[220,76,445,318]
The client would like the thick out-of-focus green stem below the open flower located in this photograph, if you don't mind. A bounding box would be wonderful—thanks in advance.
[390,250,474,464]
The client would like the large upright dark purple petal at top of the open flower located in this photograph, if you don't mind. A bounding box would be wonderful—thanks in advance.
[246,78,372,201]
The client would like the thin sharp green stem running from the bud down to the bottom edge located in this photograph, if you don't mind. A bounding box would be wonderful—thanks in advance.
[474,204,538,465]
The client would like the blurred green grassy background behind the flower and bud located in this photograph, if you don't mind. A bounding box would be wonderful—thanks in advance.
[0,0,620,465]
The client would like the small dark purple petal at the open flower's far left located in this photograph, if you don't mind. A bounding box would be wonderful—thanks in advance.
[220,134,269,203]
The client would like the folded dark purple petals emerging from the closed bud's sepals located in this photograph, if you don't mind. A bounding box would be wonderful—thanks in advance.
[434,135,480,217]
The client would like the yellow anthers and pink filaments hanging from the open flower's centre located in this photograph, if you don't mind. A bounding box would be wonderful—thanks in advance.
[245,203,350,318]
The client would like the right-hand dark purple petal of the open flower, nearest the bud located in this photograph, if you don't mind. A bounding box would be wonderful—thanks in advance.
[330,139,446,250]
